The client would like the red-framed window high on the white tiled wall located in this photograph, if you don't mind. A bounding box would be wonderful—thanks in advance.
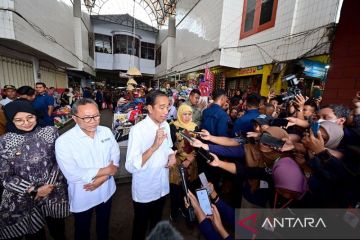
[240,0,278,38]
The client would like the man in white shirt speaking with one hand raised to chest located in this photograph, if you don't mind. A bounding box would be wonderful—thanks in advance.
[125,91,176,240]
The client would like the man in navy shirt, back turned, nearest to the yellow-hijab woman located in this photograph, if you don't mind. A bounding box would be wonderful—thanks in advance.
[201,89,230,137]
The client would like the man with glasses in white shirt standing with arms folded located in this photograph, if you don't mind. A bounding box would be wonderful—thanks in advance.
[55,98,120,240]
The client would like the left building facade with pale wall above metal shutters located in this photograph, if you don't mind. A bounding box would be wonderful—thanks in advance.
[0,0,94,90]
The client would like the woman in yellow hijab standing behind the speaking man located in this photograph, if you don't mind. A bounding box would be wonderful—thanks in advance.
[169,104,198,220]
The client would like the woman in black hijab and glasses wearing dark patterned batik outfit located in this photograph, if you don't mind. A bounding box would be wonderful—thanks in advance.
[0,101,69,240]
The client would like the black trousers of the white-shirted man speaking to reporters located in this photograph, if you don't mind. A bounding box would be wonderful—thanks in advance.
[132,196,165,240]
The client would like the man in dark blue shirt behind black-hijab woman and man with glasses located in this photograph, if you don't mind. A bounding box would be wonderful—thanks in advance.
[33,82,54,126]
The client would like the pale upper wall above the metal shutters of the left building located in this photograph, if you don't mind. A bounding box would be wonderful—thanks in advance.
[0,0,93,72]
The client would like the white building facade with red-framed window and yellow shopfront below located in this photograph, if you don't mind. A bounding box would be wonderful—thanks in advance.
[155,0,342,96]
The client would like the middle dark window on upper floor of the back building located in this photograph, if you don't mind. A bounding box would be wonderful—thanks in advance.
[114,35,139,56]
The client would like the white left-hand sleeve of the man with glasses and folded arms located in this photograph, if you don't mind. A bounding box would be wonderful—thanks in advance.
[55,138,99,183]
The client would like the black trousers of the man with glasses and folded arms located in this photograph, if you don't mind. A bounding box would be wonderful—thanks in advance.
[74,198,112,240]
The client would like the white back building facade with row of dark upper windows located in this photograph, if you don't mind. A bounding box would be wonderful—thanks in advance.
[91,14,157,87]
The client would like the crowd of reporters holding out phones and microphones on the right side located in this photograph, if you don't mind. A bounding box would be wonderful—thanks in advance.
[170,89,360,239]
